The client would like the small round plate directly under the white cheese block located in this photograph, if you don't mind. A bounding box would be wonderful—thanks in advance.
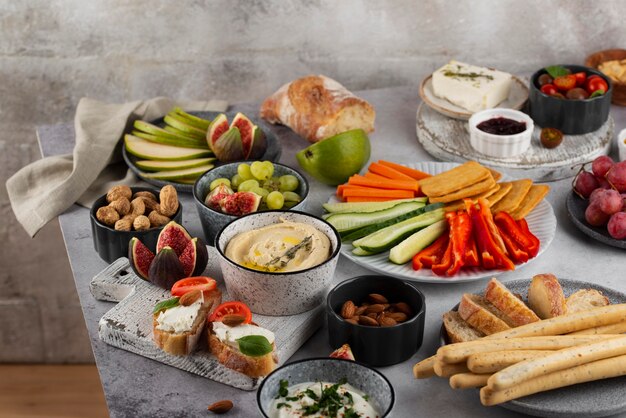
[420,74,528,120]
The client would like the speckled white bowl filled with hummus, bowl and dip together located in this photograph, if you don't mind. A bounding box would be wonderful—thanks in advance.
[215,210,341,315]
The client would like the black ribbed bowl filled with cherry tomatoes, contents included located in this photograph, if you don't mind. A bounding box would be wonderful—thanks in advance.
[529,65,613,135]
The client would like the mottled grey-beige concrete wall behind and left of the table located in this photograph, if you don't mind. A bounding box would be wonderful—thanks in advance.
[0,0,626,362]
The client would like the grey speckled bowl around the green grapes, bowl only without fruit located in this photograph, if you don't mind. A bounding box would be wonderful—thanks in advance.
[193,161,309,245]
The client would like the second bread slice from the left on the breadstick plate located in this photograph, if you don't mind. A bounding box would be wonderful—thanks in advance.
[459,293,513,335]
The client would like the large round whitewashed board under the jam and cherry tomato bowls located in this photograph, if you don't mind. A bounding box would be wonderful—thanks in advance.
[417,103,614,182]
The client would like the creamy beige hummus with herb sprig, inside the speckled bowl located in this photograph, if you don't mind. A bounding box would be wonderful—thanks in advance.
[225,219,330,272]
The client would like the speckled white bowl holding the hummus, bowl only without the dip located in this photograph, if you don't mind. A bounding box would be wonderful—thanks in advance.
[215,211,341,315]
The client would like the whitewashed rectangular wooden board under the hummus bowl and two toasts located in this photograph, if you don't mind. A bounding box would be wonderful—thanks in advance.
[90,257,323,390]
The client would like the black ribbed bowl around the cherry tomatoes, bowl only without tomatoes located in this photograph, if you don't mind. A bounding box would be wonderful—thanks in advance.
[529,65,613,135]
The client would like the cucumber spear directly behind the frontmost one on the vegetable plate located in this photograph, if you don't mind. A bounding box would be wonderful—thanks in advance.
[352,209,444,253]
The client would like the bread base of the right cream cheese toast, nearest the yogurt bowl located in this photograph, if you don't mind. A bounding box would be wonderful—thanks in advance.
[208,324,278,377]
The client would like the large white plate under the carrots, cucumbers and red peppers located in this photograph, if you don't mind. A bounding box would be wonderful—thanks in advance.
[330,162,556,283]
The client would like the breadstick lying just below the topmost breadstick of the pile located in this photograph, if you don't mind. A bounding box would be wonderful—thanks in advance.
[437,334,621,363]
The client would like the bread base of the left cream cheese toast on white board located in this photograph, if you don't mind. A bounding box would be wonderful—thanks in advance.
[152,289,222,356]
